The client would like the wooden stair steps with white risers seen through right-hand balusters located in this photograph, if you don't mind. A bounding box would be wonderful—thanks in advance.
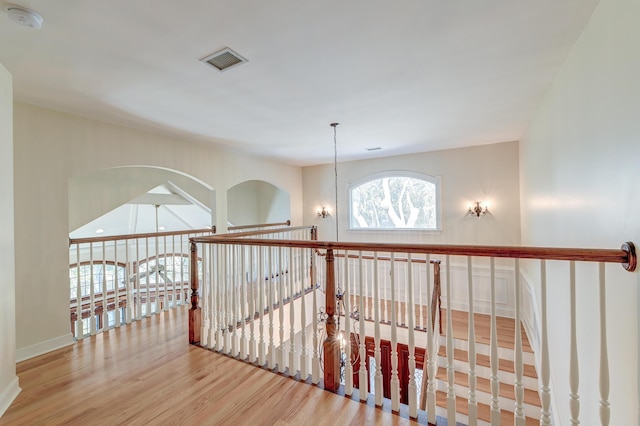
[436,311,541,425]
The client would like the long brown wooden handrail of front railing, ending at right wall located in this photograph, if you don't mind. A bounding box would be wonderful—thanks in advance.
[185,235,637,272]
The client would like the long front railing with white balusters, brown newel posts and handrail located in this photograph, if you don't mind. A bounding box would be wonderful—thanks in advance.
[190,236,635,425]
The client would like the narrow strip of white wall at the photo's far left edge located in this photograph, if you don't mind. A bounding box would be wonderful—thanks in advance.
[0,64,20,416]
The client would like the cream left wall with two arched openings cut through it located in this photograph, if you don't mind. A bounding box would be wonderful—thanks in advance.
[12,102,302,359]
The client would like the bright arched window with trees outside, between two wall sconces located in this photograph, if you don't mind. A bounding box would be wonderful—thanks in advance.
[349,172,441,231]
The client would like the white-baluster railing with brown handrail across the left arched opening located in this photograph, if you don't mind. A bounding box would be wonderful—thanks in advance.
[69,229,212,339]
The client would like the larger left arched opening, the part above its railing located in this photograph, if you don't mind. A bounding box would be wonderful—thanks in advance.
[69,166,215,238]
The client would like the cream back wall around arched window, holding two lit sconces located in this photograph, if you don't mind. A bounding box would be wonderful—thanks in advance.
[302,142,520,245]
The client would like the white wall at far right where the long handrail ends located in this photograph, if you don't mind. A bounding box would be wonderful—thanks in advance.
[520,0,640,425]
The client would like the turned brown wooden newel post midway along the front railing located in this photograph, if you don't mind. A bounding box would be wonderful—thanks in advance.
[323,249,340,392]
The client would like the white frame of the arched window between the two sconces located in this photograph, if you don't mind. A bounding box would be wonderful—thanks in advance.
[347,170,442,233]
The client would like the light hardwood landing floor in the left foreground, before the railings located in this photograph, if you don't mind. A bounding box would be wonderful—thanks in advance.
[0,308,416,426]
